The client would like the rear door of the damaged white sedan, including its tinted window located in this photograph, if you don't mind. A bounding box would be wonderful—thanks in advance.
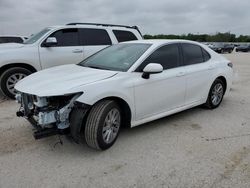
[181,43,215,105]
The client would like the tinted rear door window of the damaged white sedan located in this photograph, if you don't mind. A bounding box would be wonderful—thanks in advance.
[181,44,204,65]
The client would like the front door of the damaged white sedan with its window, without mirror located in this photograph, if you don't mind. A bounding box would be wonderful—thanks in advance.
[135,44,186,121]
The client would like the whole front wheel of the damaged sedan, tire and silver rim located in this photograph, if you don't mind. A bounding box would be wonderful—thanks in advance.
[84,100,122,150]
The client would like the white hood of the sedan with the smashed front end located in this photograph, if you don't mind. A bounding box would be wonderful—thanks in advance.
[15,65,117,97]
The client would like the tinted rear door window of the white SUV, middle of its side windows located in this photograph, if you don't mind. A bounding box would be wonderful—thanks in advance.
[79,28,112,46]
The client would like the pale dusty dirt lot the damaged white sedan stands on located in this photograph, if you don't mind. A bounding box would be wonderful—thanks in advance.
[0,53,250,188]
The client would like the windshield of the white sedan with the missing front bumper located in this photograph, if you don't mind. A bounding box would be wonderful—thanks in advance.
[79,43,151,72]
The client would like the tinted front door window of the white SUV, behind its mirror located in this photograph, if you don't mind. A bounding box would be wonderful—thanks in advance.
[50,29,79,46]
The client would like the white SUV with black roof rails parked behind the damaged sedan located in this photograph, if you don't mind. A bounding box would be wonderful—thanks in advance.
[0,23,142,98]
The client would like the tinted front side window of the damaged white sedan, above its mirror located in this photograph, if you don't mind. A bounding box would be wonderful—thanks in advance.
[137,44,180,72]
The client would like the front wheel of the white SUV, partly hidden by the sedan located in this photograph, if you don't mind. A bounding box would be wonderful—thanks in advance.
[0,67,32,99]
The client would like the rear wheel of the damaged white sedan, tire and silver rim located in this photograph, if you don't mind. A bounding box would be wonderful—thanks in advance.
[205,78,225,109]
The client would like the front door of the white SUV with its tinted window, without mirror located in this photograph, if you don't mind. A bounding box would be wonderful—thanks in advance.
[39,28,83,69]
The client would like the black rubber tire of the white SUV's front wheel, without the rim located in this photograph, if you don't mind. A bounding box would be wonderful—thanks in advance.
[0,67,32,99]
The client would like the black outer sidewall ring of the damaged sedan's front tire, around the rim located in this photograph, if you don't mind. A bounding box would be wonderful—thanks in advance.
[97,102,122,150]
